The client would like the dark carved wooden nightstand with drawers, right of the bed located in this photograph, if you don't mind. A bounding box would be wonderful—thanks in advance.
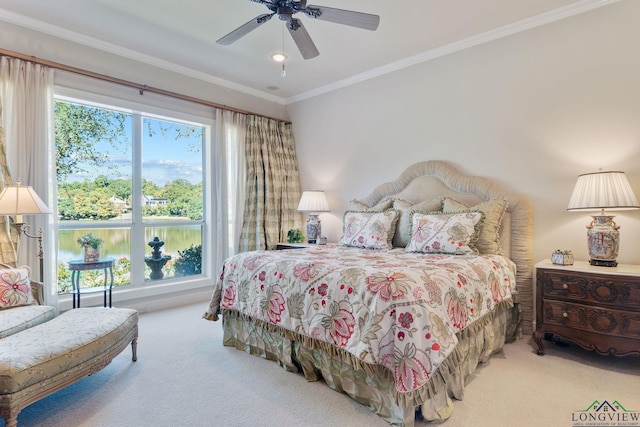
[533,260,640,356]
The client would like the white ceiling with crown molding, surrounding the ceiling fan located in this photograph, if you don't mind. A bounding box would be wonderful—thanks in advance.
[0,0,612,103]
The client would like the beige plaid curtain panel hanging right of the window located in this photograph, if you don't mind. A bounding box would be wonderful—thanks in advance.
[238,115,302,252]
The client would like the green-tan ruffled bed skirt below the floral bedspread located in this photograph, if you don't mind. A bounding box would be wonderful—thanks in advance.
[222,303,519,426]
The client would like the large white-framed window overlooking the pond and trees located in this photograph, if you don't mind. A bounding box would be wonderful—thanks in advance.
[54,91,212,294]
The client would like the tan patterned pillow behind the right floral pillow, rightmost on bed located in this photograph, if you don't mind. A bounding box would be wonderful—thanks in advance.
[442,198,508,255]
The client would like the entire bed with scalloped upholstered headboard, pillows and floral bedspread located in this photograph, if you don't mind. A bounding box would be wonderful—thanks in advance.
[204,161,533,426]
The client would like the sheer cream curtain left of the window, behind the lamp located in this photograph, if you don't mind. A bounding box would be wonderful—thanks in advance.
[0,56,57,306]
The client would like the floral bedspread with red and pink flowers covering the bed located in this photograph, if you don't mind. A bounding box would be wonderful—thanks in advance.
[205,245,515,393]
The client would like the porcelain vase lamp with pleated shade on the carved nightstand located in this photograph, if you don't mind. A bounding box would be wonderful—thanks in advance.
[567,171,640,267]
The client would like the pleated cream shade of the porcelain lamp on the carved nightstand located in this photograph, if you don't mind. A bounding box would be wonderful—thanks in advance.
[567,172,640,211]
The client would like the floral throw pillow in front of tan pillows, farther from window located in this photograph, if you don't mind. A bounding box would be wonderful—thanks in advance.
[406,211,484,255]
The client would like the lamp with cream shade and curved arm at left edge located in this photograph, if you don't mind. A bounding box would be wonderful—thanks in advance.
[0,180,51,282]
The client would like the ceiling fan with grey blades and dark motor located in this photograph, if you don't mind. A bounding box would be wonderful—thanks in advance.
[216,0,380,59]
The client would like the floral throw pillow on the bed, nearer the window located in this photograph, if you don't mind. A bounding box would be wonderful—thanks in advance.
[340,209,398,249]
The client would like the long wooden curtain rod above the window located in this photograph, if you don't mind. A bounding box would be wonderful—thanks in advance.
[0,48,291,124]
